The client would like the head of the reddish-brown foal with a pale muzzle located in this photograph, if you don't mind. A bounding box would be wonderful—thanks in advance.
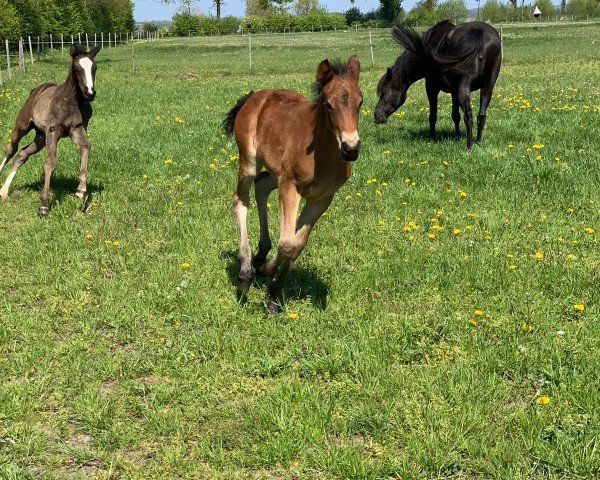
[316,56,362,161]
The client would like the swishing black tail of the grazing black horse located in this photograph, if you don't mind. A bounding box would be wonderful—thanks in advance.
[428,28,484,73]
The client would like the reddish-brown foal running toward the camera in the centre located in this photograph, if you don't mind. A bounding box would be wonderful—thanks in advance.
[223,56,362,314]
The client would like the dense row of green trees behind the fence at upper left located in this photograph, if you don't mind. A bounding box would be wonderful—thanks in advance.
[0,0,135,40]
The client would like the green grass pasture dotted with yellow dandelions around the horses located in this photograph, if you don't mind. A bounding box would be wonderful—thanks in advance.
[0,23,600,480]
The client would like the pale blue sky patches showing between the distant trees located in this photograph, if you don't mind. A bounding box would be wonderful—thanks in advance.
[134,0,477,22]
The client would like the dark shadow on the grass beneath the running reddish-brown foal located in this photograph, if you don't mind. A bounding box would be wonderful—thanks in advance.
[220,251,329,310]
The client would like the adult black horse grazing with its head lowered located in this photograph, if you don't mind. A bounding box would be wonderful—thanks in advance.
[375,20,502,148]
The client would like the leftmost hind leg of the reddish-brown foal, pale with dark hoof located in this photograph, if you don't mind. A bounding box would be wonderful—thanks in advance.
[232,151,256,295]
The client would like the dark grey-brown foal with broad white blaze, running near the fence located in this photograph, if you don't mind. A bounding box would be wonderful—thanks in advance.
[0,45,100,215]
